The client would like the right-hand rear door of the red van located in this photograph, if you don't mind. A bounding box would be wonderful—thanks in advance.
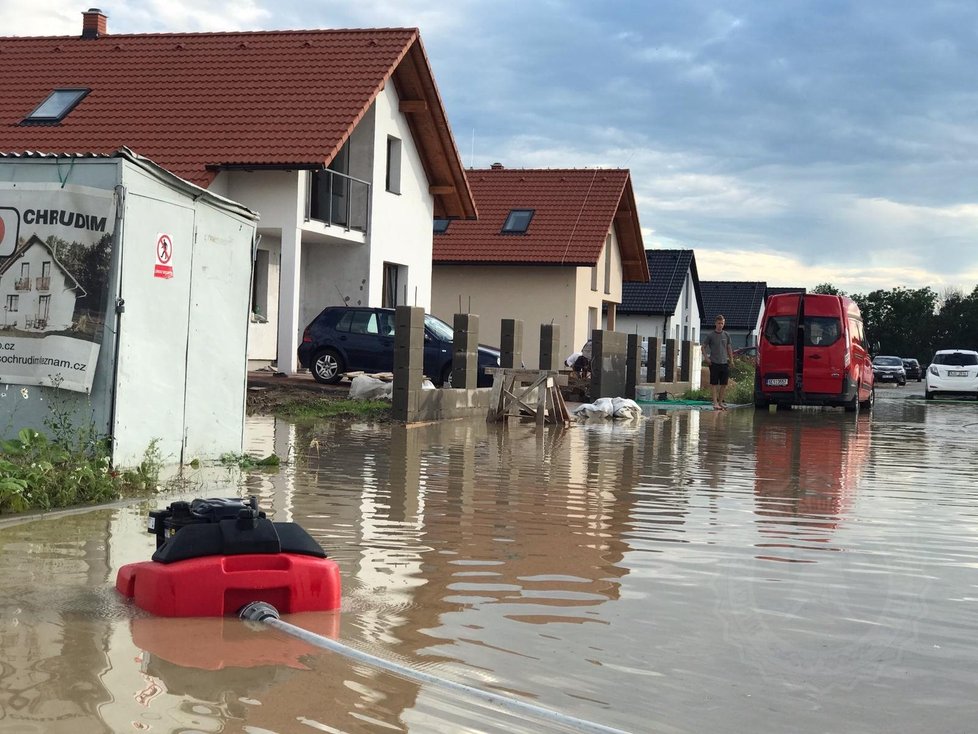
[801,296,847,395]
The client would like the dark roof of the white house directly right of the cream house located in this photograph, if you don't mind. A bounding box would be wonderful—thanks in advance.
[617,250,703,316]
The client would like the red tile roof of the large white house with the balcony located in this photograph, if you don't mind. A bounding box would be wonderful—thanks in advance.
[0,28,475,217]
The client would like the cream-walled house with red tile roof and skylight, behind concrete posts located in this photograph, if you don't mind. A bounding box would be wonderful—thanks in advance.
[431,163,649,368]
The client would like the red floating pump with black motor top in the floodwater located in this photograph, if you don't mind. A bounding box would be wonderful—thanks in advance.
[115,497,340,617]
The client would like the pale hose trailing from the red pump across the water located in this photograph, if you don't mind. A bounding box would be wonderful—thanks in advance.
[239,602,628,734]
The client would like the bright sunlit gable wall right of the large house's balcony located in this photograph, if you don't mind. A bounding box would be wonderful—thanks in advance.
[364,84,434,311]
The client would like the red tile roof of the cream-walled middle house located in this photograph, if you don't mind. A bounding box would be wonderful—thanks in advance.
[433,168,649,281]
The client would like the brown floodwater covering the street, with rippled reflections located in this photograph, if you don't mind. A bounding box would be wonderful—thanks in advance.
[0,386,978,734]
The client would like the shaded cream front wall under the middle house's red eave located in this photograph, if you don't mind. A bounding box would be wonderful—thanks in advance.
[431,265,576,369]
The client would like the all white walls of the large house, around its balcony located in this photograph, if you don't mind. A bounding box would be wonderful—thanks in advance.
[210,84,434,373]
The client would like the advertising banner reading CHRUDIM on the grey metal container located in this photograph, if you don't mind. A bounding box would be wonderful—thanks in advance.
[0,187,116,393]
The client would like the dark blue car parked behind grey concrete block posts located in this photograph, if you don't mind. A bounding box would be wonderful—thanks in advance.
[298,306,499,387]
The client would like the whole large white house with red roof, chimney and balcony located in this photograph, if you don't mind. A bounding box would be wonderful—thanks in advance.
[0,9,476,373]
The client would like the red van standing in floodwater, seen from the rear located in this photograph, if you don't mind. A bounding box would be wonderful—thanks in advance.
[754,293,876,411]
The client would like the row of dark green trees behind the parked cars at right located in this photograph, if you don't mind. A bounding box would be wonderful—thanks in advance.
[813,283,978,365]
